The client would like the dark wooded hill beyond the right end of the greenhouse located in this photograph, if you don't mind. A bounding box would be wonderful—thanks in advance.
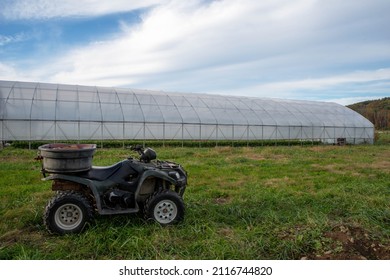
[347,97,390,130]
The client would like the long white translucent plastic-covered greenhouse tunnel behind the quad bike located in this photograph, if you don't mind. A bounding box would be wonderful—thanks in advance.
[0,81,374,143]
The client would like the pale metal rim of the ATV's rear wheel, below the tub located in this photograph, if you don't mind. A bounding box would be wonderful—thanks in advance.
[54,203,83,230]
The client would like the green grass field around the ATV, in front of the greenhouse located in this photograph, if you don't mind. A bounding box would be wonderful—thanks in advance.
[0,141,390,259]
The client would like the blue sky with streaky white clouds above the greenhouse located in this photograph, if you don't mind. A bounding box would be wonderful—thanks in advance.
[0,0,390,105]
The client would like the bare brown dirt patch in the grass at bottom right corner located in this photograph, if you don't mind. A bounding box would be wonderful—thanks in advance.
[302,225,390,260]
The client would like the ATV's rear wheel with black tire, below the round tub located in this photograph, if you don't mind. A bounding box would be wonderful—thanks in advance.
[44,192,93,234]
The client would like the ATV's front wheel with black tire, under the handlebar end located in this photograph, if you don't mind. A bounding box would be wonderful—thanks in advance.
[144,190,184,225]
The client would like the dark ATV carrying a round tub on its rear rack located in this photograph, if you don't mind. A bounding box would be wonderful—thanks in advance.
[38,143,187,234]
